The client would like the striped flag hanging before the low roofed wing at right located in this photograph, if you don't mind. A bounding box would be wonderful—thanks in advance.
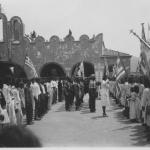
[116,53,126,80]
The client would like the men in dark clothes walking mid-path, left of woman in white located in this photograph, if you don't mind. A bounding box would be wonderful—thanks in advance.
[64,75,97,112]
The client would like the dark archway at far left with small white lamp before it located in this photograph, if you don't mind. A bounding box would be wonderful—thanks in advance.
[0,61,27,80]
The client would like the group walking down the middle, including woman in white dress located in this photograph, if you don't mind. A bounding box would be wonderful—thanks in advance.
[64,74,110,117]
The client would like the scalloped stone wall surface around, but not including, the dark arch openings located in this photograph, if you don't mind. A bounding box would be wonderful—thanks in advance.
[0,14,131,81]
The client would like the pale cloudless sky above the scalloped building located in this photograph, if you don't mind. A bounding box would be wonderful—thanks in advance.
[0,0,150,57]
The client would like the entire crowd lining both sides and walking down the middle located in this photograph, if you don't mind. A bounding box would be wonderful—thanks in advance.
[0,71,150,145]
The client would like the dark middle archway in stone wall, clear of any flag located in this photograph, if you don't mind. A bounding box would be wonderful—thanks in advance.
[40,62,66,78]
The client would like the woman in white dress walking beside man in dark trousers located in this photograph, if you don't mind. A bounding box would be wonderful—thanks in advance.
[100,81,110,117]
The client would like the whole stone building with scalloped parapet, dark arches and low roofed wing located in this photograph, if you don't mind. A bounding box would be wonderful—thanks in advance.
[0,13,131,80]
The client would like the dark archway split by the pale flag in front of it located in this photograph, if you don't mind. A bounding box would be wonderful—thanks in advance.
[71,61,95,77]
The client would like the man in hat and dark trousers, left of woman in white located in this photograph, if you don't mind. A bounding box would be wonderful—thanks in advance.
[89,74,97,112]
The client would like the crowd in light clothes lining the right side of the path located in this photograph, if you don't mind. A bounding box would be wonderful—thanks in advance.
[110,76,150,140]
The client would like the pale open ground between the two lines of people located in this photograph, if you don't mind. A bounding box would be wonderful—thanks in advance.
[27,96,150,147]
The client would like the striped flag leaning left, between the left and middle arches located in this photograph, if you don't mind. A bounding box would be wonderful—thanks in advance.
[25,55,38,78]
